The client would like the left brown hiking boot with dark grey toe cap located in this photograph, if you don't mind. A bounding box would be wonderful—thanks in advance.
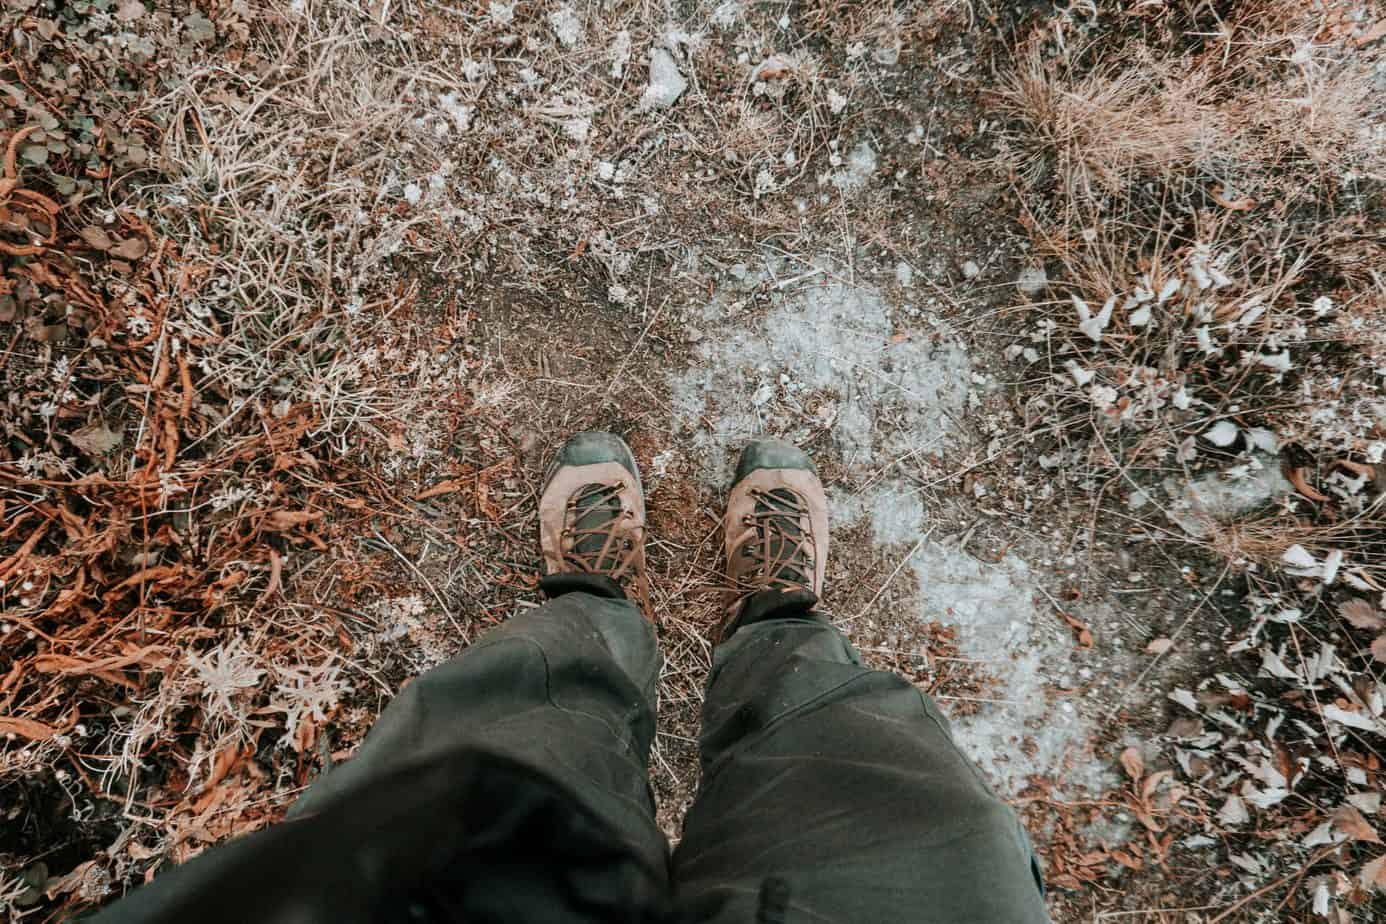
[539,432,650,618]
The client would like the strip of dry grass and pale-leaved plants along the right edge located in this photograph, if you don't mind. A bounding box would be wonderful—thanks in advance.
[995,1,1386,920]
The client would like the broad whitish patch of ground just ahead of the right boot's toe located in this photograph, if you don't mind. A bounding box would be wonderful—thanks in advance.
[671,260,972,488]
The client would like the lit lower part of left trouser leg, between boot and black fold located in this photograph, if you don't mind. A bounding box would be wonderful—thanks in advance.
[290,593,663,839]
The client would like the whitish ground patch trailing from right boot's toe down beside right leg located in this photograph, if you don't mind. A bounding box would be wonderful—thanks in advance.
[669,259,1107,797]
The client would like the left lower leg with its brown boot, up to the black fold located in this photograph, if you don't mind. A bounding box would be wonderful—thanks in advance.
[291,434,660,830]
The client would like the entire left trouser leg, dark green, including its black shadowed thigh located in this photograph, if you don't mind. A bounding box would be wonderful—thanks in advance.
[89,587,669,924]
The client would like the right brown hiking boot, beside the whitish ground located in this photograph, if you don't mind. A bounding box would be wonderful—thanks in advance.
[722,439,827,634]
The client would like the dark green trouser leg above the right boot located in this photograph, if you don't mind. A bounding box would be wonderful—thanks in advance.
[674,609,1048,924]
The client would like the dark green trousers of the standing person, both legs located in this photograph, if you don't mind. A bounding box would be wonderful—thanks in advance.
[97,579,1048,924]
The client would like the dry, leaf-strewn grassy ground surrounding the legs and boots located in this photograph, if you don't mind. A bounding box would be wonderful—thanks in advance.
[0,0,1386,924]
